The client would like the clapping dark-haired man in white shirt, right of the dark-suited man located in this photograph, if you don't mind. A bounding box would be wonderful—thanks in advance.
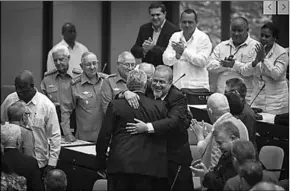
[163,9,212,92]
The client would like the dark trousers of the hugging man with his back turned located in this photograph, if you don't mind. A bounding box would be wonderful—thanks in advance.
[108,173,167,191]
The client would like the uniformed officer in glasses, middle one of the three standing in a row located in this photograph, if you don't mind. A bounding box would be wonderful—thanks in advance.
[64,52,106,142]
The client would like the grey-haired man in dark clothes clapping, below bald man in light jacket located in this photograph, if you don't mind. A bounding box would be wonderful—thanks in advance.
[190,121,240,191]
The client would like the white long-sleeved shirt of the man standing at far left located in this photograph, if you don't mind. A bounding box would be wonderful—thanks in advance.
[1,92,61,168]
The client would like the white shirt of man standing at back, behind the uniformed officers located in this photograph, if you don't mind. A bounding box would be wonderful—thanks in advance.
[47,40,88,73]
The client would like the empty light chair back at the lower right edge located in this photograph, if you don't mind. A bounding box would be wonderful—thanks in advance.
[259,146,284,179]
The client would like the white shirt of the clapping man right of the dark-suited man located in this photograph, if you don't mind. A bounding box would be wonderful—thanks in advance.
[163,28,212,90]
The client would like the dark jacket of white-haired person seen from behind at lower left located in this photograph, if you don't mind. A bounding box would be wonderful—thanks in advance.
[3,148,44,191]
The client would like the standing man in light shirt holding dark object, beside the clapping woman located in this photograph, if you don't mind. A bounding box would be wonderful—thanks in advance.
[207,16,258,103]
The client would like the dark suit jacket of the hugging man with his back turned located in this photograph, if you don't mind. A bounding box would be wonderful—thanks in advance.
[96,93,167,177]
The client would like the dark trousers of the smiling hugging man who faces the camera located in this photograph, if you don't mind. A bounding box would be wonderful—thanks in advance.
[168,161,194,191]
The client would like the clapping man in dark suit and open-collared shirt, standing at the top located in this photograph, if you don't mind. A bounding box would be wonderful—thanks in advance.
[131,2,179,66]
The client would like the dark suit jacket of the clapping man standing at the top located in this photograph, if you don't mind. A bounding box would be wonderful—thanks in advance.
[131,21,179,66]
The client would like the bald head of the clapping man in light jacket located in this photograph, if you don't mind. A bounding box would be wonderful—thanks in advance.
[207,93,230,122]
